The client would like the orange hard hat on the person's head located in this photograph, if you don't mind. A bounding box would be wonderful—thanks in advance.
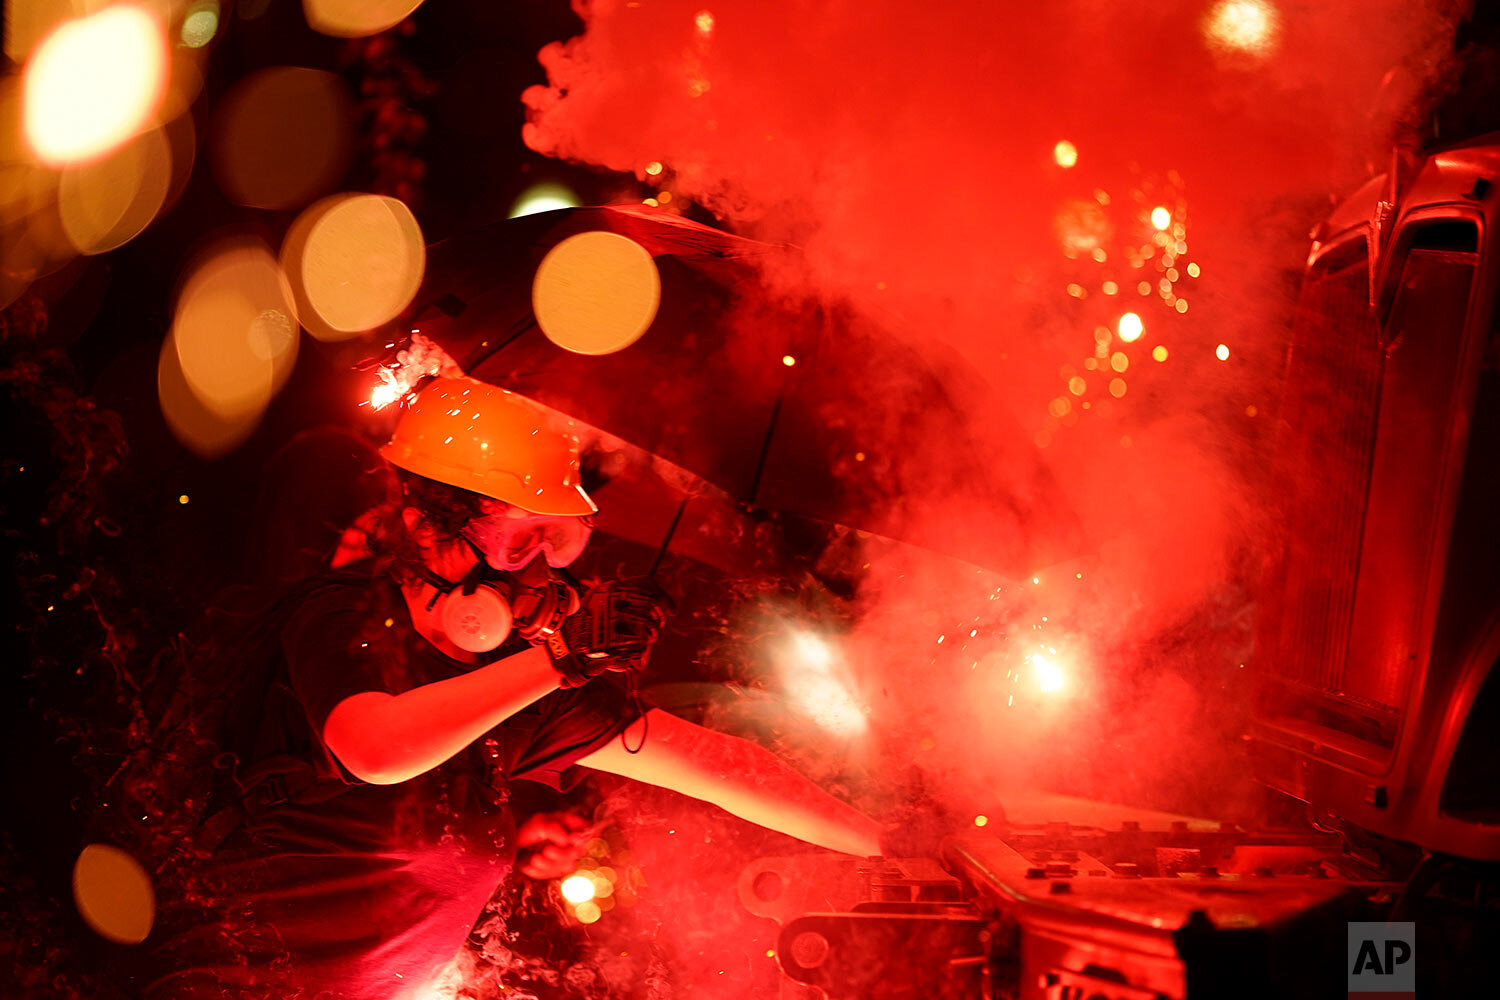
[380,376,599,514]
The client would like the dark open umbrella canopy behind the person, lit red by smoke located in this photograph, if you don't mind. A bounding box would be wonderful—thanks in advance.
[411,207,1082,576]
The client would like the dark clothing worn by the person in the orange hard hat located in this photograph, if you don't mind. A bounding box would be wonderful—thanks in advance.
[147,564,638,1000]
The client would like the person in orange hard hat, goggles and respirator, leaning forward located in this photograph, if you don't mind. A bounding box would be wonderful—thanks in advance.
[147,378,879,1000]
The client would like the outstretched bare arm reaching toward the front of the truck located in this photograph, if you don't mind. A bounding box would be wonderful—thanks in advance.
[579,709,881,856]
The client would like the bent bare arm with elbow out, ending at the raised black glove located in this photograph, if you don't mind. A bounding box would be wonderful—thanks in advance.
[323,648,560,784]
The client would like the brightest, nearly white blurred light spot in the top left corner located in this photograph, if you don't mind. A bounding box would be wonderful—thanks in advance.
[21,3,168,166]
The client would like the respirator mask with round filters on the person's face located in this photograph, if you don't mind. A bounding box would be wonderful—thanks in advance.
[417,539,588,654]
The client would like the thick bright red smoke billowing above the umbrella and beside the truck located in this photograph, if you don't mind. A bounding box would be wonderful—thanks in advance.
[525,0,1454,875]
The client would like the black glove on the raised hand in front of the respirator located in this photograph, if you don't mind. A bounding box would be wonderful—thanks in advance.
[537,582,668,688]
